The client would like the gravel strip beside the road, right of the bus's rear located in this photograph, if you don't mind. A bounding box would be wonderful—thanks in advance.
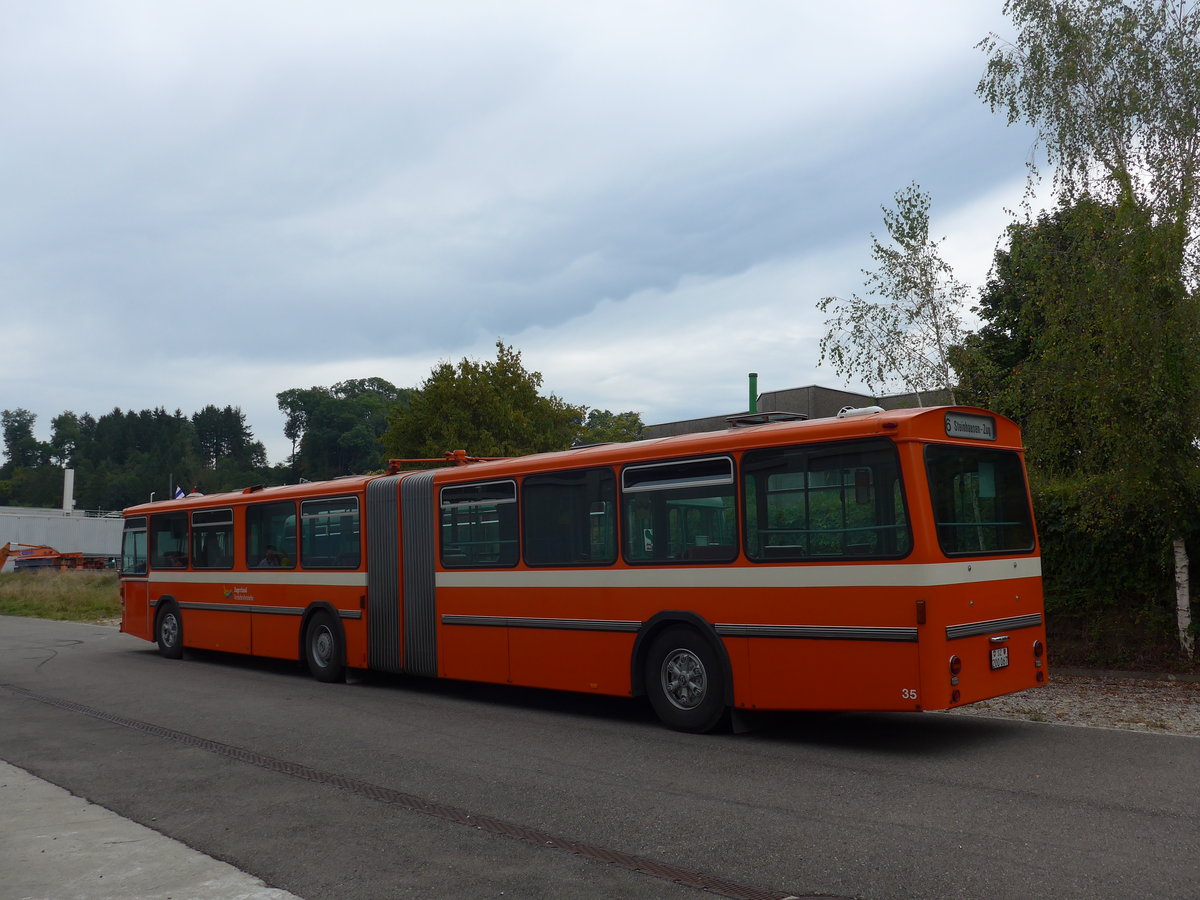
[949,672,1200,737]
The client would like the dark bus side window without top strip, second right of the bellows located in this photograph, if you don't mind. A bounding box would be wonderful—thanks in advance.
[521,469,617,565]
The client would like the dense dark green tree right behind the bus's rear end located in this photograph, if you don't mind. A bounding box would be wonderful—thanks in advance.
[954,200,1200,649]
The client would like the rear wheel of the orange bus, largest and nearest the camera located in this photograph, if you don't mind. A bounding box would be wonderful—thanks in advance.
[646,625,726,734]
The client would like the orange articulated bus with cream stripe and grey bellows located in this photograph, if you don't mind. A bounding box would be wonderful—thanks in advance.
[121,407,1046,732]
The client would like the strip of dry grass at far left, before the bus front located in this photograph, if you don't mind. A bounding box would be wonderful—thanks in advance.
[0,572,121,622]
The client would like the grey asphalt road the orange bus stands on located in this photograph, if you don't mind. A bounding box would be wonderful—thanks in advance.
[0,617,1200,900]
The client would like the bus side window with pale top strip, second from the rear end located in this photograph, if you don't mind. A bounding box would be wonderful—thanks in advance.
[620,456,738,563]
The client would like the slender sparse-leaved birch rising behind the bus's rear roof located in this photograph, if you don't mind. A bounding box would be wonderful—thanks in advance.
[817,182,967,402]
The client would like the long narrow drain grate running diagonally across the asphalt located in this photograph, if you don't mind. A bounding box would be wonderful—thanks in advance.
[4,685,811,900]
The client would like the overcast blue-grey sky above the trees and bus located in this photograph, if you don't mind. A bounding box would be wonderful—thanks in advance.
[0,0,1032,462]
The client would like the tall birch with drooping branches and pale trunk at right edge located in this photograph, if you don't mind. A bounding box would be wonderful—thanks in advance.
[978,0,1200,656]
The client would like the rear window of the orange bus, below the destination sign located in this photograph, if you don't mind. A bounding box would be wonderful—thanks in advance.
[925,444,1033,556]
